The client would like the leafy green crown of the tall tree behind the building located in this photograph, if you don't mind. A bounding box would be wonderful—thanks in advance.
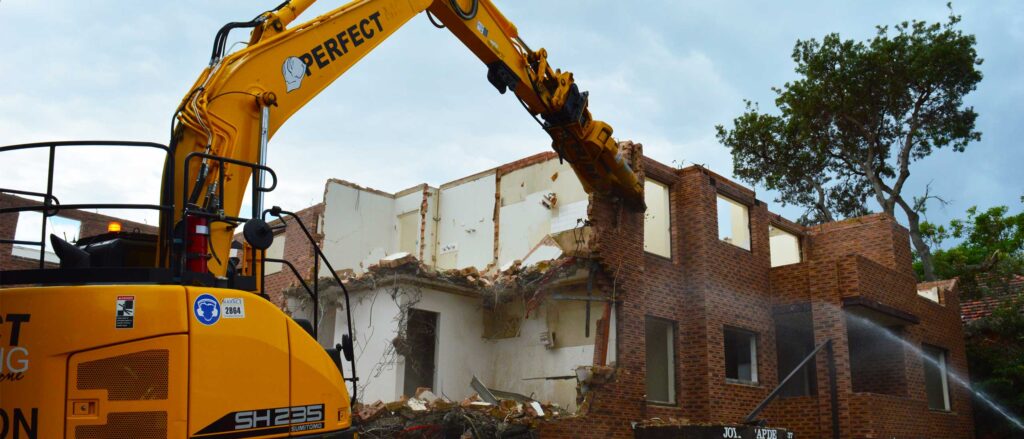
[716,9,982,228]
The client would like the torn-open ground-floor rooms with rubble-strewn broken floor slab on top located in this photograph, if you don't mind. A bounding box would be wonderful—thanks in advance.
[286,249,614,418]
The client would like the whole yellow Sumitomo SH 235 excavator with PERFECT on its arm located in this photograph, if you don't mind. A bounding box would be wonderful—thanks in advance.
[0,0,643,439]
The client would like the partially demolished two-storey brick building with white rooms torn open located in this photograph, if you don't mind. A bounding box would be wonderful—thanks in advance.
[268,142,973,438]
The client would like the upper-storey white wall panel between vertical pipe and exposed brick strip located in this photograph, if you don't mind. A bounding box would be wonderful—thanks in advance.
[437,170,497,269]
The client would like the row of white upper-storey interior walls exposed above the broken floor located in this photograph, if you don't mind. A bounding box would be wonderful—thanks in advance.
[323,159,588,273]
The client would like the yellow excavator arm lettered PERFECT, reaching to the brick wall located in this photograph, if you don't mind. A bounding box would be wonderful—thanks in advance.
[167,0,643,275]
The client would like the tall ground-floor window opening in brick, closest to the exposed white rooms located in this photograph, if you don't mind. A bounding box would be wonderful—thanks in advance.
[644,316,676,404]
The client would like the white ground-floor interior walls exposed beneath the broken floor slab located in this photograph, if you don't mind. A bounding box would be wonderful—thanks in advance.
[323,287,598,410]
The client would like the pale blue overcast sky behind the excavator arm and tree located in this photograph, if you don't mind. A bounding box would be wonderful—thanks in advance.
[0,0,1024,236]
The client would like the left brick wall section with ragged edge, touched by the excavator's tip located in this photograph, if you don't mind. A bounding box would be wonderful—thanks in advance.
[542,148,776,437]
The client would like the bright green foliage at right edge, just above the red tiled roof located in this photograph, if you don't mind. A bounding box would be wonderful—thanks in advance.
[914,202,1024,298]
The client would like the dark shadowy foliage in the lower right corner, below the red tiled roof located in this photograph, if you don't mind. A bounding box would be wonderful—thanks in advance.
[965,294,1024,438]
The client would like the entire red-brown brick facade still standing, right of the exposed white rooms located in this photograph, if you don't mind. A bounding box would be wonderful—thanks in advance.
[543,144,973,438]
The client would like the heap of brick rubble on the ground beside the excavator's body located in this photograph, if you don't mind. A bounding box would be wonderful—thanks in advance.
[353,388,566,439]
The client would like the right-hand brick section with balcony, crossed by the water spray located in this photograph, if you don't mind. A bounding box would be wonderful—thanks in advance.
[765,215,973,438]
